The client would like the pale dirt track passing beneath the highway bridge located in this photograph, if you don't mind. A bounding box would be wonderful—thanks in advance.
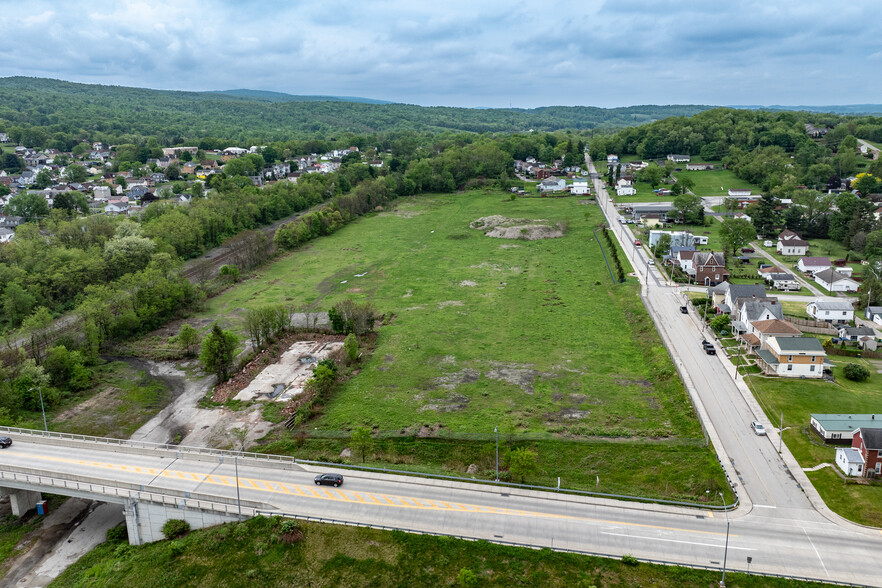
[6,357,272,588]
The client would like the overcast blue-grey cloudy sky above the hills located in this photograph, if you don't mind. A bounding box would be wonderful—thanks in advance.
[0,0,882,108]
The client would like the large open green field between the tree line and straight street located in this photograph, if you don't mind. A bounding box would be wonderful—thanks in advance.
[201,192,725,500]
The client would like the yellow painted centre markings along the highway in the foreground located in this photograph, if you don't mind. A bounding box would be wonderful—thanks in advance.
[20,455,732,537]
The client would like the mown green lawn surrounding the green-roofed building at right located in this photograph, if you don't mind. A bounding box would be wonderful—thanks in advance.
[747,356,882,525]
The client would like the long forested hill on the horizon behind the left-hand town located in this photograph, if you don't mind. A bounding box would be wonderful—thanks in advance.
[0,77,710,144]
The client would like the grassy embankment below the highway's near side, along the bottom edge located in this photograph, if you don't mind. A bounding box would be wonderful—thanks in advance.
[52,517,821,588]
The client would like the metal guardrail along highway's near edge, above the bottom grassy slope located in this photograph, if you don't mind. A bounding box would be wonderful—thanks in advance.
[255,510,868,588]
